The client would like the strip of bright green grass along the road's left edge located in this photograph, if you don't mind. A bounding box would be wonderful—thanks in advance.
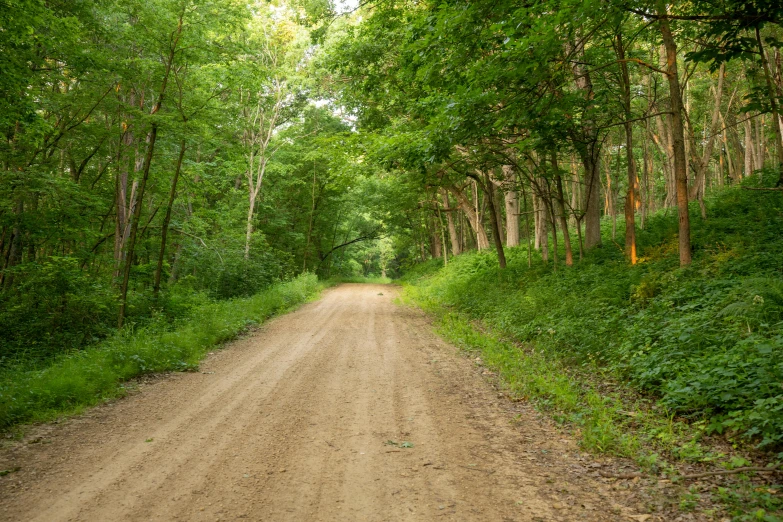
[0,274,324,431]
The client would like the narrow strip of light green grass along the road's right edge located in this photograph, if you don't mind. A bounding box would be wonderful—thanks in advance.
[399,284,783,522]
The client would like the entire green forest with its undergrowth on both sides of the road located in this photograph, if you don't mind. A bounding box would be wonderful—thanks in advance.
[0,0,783,516]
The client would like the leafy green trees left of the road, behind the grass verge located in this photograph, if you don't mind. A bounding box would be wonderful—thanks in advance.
[0,0,392,366]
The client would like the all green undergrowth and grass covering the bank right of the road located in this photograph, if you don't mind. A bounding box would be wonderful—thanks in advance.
[403,182,783,520]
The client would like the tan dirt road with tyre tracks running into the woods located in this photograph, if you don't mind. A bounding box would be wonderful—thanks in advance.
[0,285,653,522]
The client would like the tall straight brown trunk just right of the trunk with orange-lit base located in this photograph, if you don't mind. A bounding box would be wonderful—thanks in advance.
[658,0,691,266]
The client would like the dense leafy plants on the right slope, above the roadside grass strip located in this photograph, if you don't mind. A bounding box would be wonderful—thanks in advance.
[406,186,783,448]
